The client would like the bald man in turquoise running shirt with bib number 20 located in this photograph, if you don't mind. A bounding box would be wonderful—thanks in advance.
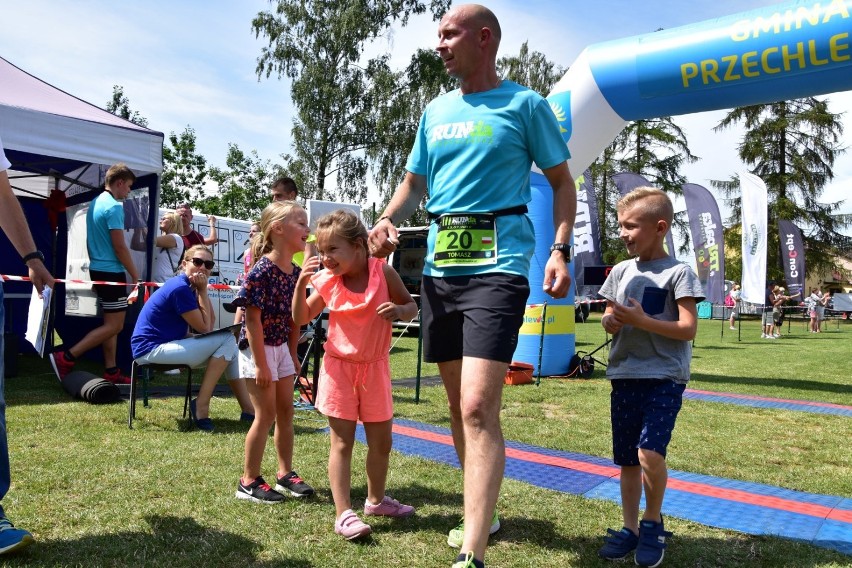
[370,4,577,568]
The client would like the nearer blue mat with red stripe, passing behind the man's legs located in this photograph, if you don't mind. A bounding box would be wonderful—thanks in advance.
[358,420,852,555]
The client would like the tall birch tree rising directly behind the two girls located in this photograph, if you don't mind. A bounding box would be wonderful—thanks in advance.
[252,0,450,201]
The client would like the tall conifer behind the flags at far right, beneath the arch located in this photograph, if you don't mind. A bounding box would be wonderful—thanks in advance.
[713,97,852,279]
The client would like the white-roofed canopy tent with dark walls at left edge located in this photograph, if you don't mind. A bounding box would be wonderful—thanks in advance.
[0,58,163,368]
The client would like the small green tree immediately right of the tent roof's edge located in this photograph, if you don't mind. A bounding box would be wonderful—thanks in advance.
[160,125,207,208]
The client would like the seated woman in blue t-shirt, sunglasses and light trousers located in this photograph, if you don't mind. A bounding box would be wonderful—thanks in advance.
[130,245,254,432]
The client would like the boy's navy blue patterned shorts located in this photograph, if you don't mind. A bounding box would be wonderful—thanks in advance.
[610,379,686,466]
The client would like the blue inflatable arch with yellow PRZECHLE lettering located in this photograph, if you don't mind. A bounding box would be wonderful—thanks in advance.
[515,0,852,375]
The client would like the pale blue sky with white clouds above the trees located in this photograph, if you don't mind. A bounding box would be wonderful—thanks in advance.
[0,0,852,220]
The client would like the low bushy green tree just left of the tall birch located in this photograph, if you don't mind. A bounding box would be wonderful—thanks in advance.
[203,144,283,219]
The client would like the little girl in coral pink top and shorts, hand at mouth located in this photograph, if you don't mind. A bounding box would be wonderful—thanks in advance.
[293,210,417,540]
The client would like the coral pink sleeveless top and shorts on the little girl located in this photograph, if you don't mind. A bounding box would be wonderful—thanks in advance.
[311,258,393,422]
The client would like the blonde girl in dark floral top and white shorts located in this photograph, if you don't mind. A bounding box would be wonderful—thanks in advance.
[234,201,314,503]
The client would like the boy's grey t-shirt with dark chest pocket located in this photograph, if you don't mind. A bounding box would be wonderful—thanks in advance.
[599,257,704,384]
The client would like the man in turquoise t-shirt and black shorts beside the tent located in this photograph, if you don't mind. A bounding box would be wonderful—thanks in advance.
[50,164,139,384]
